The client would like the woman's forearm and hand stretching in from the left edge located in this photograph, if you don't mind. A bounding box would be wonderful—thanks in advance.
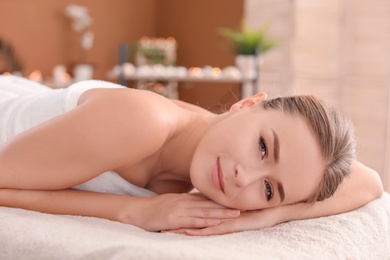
[0,189,240,231]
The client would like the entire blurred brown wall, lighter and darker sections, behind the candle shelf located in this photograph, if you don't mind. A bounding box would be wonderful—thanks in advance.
[0,0,243,107]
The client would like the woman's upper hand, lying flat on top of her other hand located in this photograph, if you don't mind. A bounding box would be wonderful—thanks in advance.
[119,193,240,231]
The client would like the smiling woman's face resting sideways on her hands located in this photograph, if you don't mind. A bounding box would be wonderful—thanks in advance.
[190,106,325,210]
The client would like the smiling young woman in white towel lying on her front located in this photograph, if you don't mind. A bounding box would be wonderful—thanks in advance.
[0,76,382,235]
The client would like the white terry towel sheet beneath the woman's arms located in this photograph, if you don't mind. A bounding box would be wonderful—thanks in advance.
[0,193,390,260]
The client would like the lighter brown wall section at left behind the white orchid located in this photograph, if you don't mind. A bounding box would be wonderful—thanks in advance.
[0,0,156,78]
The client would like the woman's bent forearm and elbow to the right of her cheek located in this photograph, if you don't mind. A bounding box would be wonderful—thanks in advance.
[278,162,383,222]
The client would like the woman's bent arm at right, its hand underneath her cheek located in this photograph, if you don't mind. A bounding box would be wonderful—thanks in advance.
[185,162,383,235]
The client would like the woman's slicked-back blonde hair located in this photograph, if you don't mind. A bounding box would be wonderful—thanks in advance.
[262,95,356,203]
